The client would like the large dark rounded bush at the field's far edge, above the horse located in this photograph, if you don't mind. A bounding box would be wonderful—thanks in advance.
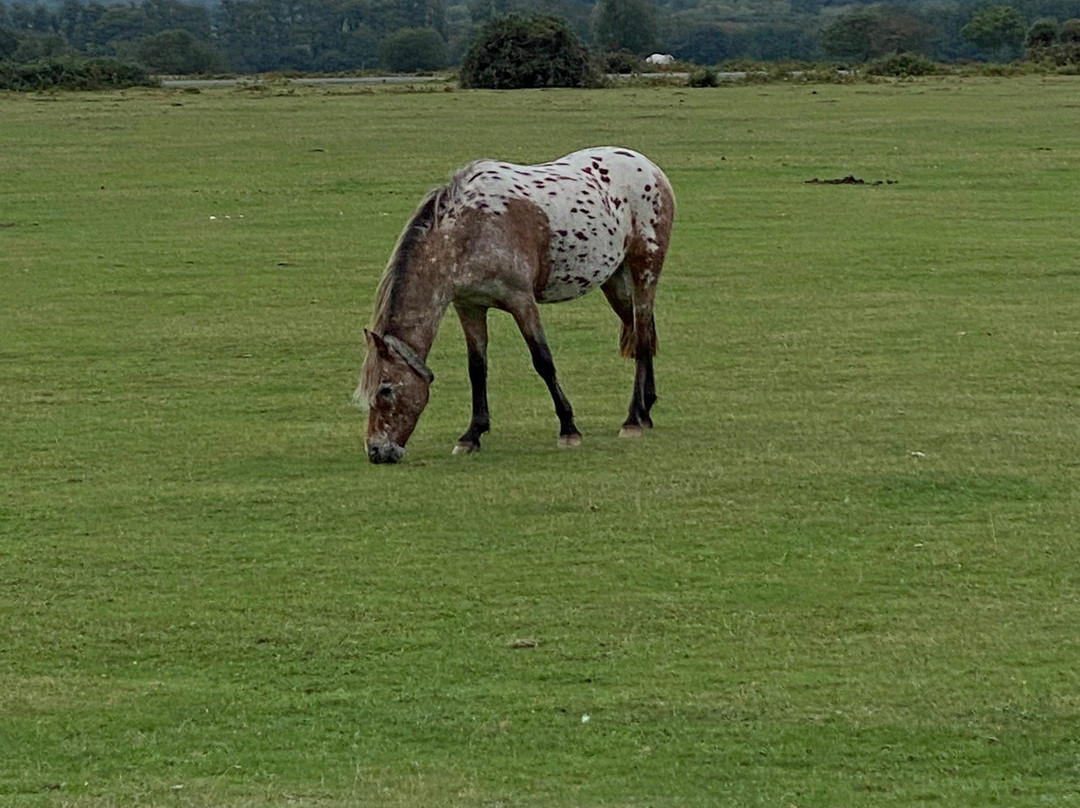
[461,15,595,90]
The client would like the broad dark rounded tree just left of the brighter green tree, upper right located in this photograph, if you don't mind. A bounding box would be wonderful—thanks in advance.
[821,6,930,62]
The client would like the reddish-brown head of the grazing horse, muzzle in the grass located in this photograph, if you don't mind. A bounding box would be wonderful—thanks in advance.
[352,331,434,463]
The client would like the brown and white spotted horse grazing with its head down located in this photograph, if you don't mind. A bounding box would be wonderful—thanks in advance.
[353,147,675,463]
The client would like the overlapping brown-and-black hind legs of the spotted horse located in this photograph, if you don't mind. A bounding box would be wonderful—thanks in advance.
[602,261,657,437]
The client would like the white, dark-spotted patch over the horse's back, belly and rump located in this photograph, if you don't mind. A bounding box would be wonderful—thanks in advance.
[443,147,666,302]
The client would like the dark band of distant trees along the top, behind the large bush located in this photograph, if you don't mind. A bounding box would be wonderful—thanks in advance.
[0,0,1080,73]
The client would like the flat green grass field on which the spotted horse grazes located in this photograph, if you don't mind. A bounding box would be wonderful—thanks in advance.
[0,78,1080,808]
